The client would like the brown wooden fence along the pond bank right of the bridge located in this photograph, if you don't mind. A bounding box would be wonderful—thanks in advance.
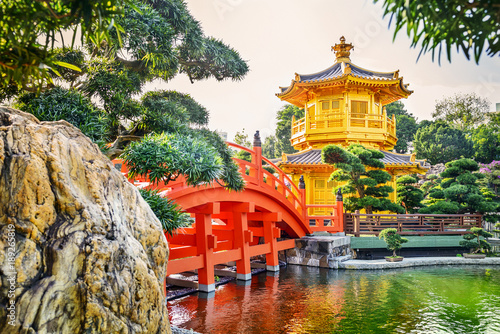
[344,212,482,237]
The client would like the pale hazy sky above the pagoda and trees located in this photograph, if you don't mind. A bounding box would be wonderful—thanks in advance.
[147,0,500,141]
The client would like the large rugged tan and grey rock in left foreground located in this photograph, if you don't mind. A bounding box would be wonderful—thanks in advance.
[0,107,170,333]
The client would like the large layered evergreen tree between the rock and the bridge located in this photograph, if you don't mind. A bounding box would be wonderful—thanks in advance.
[9,0,248,190]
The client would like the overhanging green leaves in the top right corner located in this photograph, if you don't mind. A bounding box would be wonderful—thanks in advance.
[375,0,500,63]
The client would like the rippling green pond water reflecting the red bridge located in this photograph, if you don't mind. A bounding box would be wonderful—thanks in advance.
[168,265,500,334]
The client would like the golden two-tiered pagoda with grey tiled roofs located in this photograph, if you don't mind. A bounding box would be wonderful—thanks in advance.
[275,36,429,214]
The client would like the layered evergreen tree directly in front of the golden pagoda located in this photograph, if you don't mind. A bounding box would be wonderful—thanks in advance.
[321,144,404,214]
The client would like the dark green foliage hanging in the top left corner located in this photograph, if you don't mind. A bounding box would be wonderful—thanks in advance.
[0,0,129,90]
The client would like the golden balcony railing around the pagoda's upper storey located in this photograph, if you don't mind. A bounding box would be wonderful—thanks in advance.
[292,112,396,137]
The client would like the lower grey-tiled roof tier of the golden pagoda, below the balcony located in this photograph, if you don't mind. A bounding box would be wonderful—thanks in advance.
[273,148,430,169]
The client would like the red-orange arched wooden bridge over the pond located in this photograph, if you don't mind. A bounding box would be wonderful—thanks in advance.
[115,143,344,292]
